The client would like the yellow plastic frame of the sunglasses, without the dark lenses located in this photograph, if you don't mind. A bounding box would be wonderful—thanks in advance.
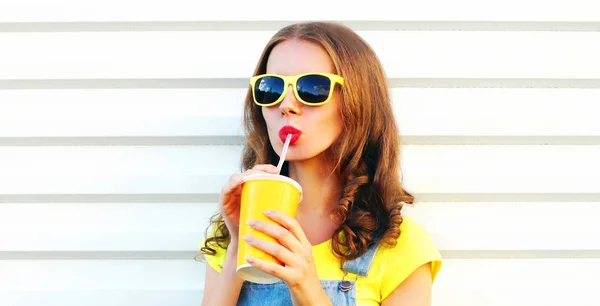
[250,72,344,106]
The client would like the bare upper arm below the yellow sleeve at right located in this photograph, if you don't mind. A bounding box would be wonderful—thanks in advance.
[381,263,433,306]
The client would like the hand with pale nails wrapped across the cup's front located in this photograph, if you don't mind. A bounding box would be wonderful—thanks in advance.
[242,211,329,305]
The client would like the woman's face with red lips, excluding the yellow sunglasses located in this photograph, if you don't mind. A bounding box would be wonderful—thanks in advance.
[262,40,342,161]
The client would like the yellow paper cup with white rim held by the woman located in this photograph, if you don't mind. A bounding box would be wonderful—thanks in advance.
[236,173,302,284]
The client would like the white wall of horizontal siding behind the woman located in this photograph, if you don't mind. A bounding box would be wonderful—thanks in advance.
[0,0,600,306]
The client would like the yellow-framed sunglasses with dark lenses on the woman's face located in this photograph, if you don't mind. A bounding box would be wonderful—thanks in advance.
[250,72,344,106]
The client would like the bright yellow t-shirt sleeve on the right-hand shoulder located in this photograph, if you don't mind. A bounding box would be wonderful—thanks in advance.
[381,217,442,300]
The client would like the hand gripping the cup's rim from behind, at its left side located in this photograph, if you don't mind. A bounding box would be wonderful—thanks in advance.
[219,165,277,240]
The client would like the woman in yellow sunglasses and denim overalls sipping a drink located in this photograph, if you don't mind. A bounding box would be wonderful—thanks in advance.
[202,22,441,306]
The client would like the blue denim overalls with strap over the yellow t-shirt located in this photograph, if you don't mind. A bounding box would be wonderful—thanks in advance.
[237,242,378,306]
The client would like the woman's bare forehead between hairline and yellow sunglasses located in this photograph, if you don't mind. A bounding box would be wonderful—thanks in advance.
[267,40,335,75]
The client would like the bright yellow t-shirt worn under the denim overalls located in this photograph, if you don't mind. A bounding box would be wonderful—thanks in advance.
[205,216,442,306]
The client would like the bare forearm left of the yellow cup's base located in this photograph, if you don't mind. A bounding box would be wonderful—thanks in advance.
[202,240,244,306]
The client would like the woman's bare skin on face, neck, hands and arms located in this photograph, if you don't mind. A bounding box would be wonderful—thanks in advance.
[202,40,432,306]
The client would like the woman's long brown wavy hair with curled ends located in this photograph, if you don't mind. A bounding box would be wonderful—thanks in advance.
[201,22,414,265]
